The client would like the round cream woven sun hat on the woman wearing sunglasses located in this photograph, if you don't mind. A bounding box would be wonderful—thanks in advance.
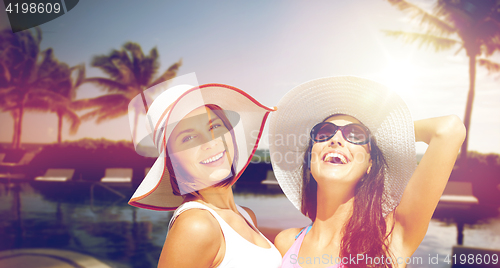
[269,76,416,216]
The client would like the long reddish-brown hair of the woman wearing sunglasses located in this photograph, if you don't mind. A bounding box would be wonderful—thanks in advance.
[301,116,395,267]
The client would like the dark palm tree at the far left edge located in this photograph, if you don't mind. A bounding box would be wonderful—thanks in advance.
[0,27,72,149]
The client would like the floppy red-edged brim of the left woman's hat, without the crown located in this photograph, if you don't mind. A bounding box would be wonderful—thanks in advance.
[129,84,275,210]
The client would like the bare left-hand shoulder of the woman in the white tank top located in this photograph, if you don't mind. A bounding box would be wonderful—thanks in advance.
[158,209,223,267]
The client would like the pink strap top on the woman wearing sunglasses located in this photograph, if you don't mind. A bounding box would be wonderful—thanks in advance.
[281,226,346,268]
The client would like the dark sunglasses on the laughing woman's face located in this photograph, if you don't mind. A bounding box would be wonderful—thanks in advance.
[311,122,370,145]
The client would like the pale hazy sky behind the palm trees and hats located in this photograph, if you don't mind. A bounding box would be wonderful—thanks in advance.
[0,0,500,153]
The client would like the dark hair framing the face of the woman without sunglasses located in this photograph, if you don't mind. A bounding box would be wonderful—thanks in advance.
[165,104,238,197]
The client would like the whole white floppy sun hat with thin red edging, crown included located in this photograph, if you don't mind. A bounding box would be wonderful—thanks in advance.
[129,84,275,210]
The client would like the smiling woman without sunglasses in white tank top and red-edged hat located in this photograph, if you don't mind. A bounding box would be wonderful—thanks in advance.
[129,84,281,268]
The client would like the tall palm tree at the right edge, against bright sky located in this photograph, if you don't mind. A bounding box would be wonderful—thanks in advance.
[385,0,500,166]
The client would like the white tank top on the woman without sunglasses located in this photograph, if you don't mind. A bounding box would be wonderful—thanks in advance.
[168,201,281,268]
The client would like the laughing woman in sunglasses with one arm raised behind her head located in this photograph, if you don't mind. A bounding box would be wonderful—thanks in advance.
[270,76,465,268]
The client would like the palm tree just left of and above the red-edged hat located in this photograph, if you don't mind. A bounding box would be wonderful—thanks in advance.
[75,42,182,140]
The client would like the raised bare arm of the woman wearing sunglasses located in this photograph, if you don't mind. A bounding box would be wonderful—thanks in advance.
[394,115,465,253]
